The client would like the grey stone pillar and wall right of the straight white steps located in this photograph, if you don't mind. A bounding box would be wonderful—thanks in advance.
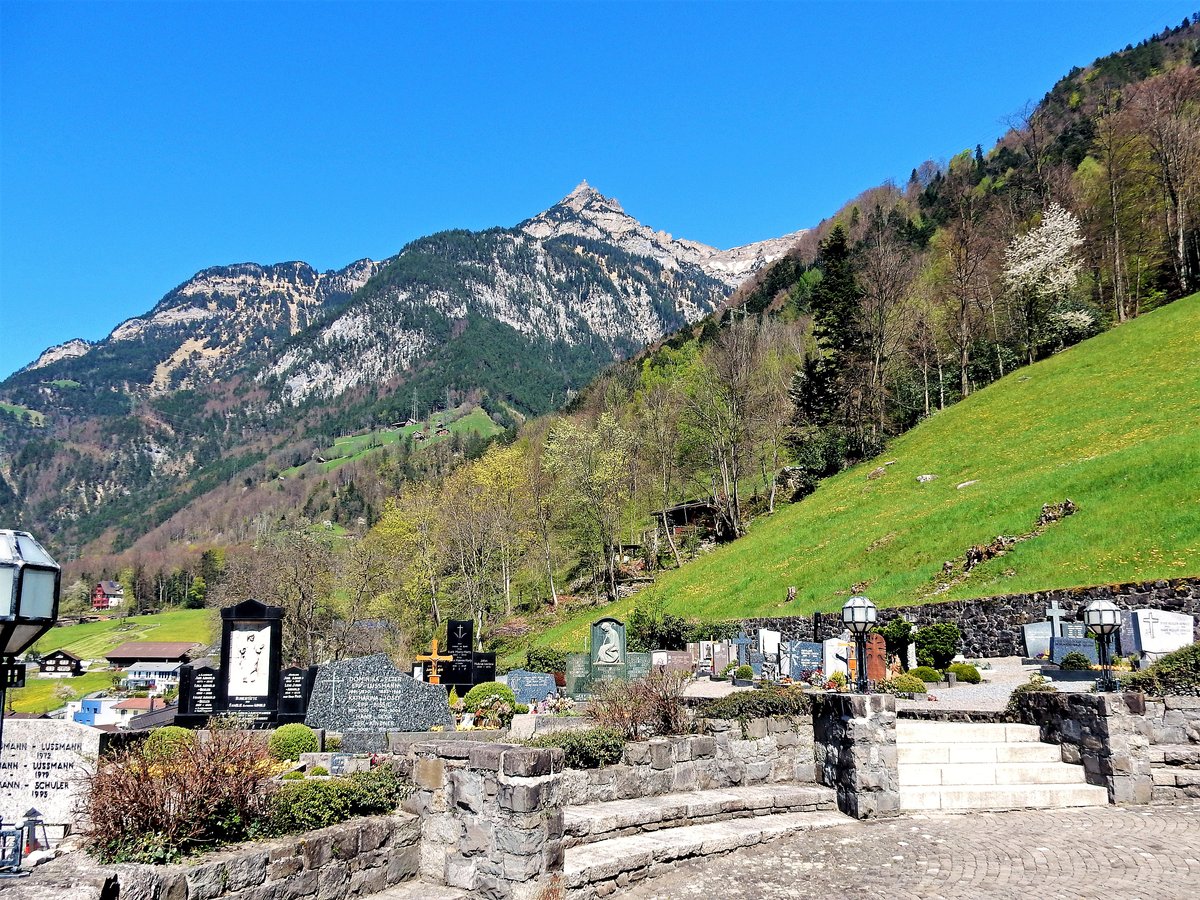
[1018,691,1153,803]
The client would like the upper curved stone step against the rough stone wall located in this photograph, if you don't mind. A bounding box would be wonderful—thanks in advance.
[563,785,838,847]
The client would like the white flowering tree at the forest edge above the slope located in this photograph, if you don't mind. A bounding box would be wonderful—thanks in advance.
[1004,203,1084,362]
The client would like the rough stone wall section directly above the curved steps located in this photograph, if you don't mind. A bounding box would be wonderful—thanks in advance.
[563,716,816,805]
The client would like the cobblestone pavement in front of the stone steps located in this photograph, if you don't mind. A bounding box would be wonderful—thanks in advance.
[614,802,1200,900]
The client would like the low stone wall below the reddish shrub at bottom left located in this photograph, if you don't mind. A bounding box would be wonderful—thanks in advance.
[38,815,420,900]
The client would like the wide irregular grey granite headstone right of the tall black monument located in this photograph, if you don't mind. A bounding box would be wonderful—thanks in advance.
[305,653,454,752]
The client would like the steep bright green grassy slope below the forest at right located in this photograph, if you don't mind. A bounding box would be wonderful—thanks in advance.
[536,295,1200,648]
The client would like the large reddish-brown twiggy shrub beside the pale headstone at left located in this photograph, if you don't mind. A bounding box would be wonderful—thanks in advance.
[84,731,274,863]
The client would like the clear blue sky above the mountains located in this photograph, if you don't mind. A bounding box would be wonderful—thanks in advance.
[0,0,1196,377]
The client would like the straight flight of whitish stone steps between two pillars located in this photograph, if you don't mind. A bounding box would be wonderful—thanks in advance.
[896,719,1109,811]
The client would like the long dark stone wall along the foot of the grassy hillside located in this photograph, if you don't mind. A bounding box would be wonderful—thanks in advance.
[744,578,1200,659]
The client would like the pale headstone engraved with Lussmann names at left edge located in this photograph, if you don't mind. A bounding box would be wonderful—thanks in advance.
[0,719,107,828]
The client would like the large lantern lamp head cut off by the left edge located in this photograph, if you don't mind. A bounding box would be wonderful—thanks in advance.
[0,529,61,656]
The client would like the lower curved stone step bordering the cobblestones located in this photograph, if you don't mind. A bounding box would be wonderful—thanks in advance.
[563,811,862,900]
